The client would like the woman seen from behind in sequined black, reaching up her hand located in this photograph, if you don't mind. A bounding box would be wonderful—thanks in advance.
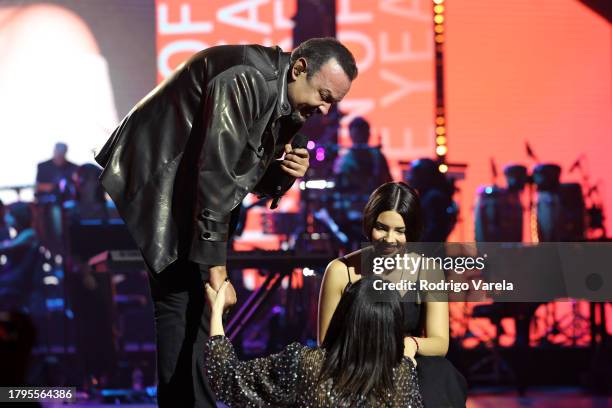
[204,277,422,407]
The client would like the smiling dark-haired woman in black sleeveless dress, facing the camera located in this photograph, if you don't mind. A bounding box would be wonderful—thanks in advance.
[318,182,467,407]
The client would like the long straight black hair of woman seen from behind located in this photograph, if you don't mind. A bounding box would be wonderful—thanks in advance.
[319,277,404,401]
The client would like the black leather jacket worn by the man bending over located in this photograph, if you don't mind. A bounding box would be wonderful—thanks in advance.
[96,45,298,272]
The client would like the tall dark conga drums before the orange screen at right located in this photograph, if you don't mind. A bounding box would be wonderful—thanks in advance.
[475,152,606,242]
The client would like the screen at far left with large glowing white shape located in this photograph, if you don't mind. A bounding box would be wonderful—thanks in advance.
[0,0,155,202]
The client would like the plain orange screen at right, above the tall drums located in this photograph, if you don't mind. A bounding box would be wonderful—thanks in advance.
[445,0,612,241]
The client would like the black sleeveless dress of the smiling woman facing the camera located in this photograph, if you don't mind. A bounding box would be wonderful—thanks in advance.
[340,258,467,408]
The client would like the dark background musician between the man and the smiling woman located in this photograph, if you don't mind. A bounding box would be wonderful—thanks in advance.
[331,117,392,250]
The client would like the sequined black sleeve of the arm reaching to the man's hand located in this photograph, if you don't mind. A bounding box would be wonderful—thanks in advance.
[204,336,304,407]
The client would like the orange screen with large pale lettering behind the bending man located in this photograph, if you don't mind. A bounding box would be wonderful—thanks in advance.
[157,0,434,246]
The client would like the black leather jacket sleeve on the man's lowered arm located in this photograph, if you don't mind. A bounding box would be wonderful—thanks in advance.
[189,66,268,266]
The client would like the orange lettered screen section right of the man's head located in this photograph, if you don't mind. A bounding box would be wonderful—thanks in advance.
[336,0,435,167]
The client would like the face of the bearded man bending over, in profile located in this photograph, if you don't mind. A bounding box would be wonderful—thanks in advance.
[287,58,351,123]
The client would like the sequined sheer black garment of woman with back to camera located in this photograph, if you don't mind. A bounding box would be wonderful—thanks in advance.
[204,336,423,408]
